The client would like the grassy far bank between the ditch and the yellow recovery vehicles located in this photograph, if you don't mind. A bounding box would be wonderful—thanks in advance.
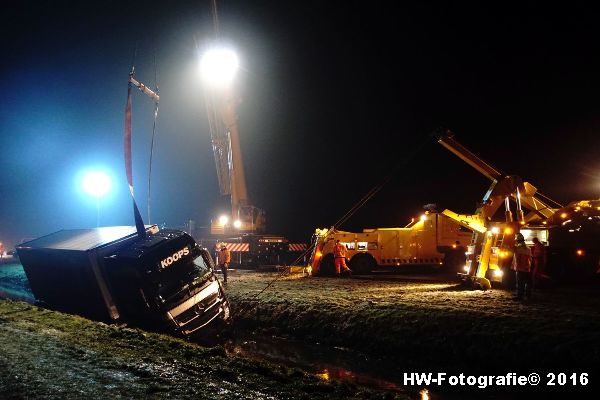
[228,273,600,394]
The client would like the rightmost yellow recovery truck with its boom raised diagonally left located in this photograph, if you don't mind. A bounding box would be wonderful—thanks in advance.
[437,130,600,289]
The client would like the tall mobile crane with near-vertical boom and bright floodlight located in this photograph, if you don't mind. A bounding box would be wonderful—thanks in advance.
[202,44,305,267]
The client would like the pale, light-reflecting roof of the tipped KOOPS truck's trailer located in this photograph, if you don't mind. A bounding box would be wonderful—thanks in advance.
[17,226,137,250]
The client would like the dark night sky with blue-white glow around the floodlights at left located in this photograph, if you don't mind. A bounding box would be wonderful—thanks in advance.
[0,0,600,247]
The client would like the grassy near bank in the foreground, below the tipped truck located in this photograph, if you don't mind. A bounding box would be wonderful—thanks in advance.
[0,265,414,399]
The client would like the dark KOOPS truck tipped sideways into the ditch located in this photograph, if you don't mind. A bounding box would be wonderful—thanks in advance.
[17,225,230,338]
